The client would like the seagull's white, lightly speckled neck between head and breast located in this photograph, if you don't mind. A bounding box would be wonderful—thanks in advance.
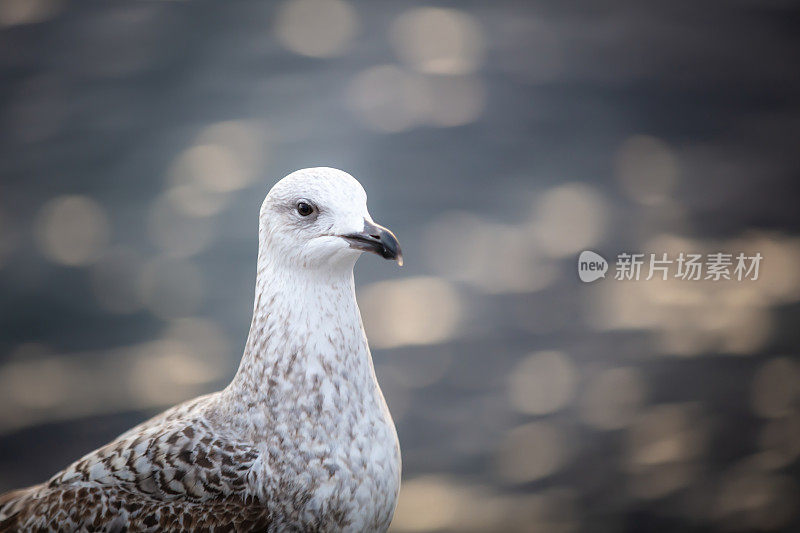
[230,264,374,403]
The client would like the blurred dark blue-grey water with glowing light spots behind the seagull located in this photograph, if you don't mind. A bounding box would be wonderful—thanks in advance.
[0,0,800,532]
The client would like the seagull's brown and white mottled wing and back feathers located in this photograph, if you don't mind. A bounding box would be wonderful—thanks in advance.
[0,396,271,531]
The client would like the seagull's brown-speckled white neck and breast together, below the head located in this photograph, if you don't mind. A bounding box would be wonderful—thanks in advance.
[212,227,400,531]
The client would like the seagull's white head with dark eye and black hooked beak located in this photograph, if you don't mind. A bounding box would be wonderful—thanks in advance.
[259,167,403,269]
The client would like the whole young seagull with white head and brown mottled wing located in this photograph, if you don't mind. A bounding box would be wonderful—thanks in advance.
[0,167,402,532]
